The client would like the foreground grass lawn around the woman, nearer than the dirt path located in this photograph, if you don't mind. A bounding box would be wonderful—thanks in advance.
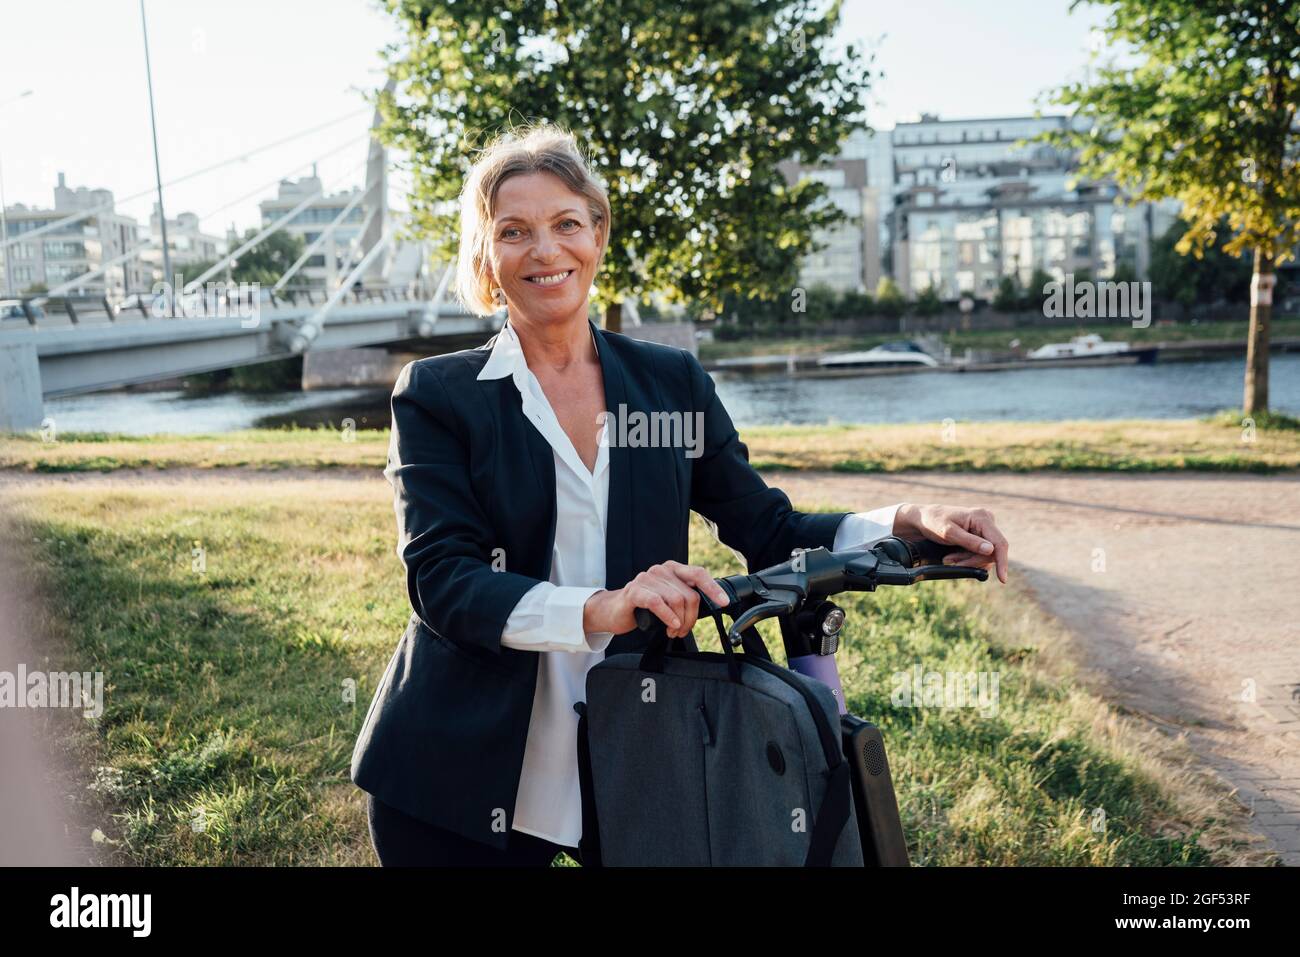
[0,475,1258,866]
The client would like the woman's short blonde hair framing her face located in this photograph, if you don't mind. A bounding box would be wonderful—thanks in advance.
[455,124,611,316]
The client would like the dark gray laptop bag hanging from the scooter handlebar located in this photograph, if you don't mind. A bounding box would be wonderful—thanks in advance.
[575,618,863,867]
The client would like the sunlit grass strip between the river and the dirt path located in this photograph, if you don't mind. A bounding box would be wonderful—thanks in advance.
[0,412,1300,472]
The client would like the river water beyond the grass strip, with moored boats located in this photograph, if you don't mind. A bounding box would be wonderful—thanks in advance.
[46,354,1300,434]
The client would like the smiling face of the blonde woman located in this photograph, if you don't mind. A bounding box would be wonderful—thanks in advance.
[490,173,602,330]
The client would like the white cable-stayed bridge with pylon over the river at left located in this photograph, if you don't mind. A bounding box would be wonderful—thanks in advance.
[0,87,504,432]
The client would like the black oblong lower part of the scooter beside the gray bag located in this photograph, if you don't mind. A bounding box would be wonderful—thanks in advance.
[840,714,910,867]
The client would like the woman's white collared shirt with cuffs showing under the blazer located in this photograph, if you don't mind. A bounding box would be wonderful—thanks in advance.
[478,321,898,848]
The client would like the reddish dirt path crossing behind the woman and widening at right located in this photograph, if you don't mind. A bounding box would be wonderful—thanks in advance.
[0,468,1300,866]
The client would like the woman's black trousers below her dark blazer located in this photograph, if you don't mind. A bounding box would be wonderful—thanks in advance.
[367,794,581,867]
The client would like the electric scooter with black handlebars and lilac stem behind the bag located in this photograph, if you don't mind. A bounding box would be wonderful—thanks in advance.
[636,537,988,867]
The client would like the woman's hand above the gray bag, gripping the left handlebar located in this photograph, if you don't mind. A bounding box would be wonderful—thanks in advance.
[582,562,731,638]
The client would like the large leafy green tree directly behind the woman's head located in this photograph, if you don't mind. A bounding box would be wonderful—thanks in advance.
[376,0,870,329]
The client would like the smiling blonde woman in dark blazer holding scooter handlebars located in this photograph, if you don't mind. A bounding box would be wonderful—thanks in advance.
[351,126,1008,866]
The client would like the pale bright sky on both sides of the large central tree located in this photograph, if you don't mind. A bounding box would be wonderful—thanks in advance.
[0,0,1101,235]
